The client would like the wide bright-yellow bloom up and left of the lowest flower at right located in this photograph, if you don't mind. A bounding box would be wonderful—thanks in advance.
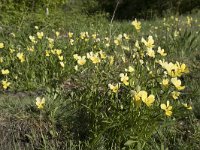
[138,91,155,107]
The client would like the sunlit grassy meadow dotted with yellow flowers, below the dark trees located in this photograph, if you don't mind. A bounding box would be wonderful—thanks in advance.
[0,3,200,150]
